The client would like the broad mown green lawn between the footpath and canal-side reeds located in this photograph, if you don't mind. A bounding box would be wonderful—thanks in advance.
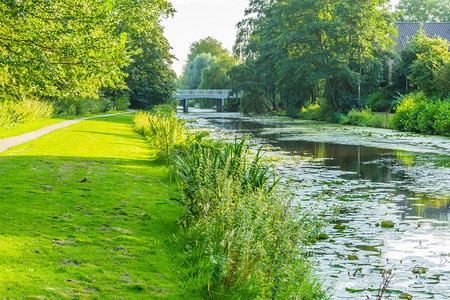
[0,114,185,299]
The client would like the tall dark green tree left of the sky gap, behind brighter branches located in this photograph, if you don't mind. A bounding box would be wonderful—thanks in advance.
[108,0,176,108]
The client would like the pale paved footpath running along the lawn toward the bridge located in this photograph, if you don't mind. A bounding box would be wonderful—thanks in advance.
[0,109,134,153]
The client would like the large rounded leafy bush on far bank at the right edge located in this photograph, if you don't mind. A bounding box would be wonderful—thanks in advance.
[392,93,450,136]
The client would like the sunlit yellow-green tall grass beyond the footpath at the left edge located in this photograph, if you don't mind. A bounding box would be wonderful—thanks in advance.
[0,98,53,127]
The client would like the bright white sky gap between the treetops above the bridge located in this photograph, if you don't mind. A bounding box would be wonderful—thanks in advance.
[162,0,248,75]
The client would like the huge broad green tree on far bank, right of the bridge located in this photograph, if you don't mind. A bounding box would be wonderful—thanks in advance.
[233,0,394,115]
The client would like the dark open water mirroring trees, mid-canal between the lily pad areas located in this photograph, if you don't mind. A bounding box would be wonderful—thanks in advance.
[210,119,450,221]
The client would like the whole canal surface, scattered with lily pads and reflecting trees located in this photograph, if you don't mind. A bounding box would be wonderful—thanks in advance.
[180,110,450,299]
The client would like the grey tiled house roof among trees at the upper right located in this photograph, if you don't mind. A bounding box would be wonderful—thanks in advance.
[395,22,450,48]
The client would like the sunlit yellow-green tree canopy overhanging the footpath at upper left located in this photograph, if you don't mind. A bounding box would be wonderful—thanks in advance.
[0,0,172,103]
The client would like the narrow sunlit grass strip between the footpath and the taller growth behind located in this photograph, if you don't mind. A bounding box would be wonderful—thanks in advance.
[0,111,128,139]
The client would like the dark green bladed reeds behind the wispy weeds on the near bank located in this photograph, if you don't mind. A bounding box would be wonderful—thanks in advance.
[176,139,278,219]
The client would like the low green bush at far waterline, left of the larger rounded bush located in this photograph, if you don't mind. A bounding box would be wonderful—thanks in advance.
[341,108,391,128]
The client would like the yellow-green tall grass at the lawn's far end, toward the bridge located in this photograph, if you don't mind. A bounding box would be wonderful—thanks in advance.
[133,106,188,161]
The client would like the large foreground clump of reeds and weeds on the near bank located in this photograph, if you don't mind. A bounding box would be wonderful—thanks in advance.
[176,141,326,299]
